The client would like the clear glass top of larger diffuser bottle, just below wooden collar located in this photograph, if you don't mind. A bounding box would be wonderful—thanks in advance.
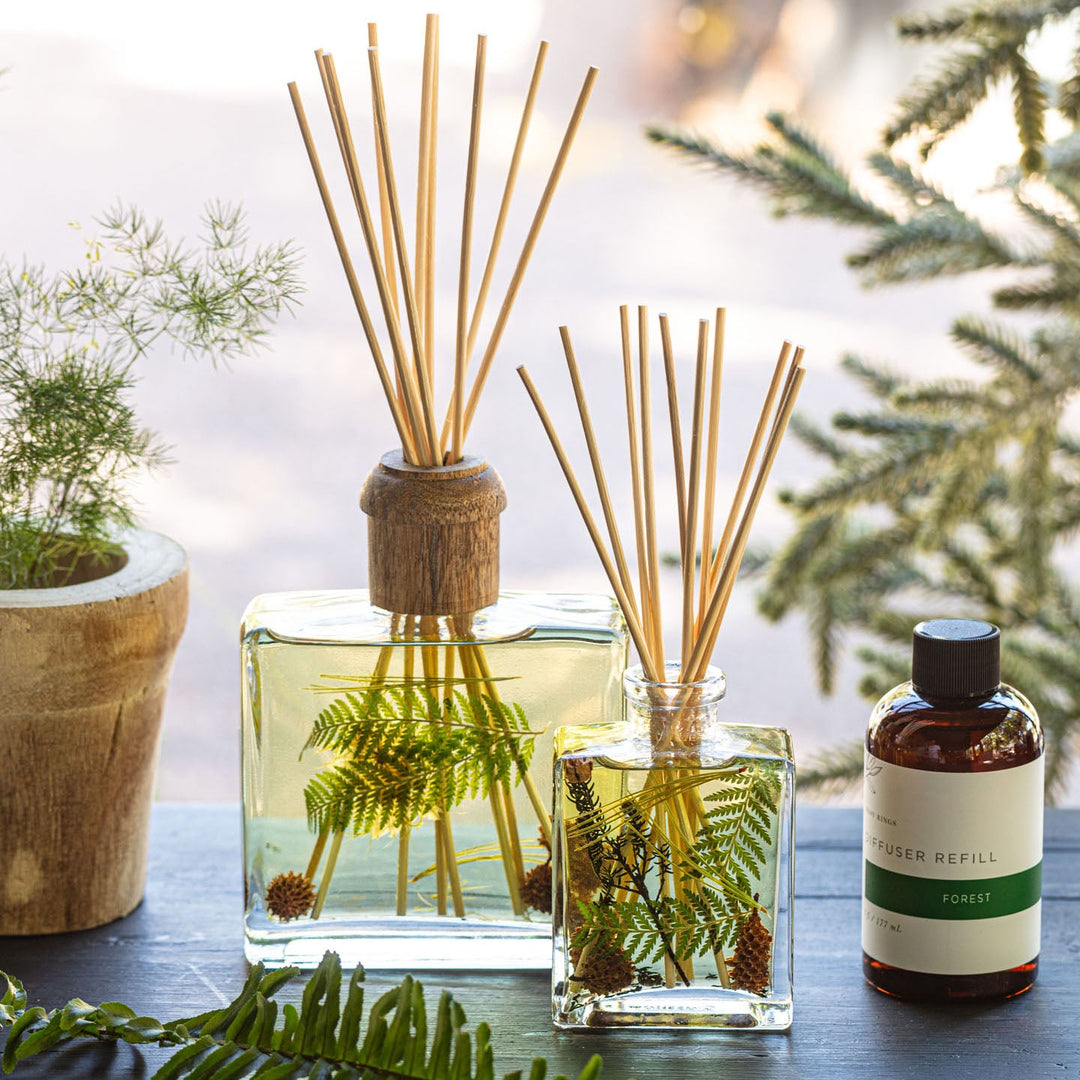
[241,589,626,645]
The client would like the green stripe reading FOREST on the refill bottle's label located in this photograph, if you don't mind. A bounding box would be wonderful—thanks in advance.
[863,860,1042,919]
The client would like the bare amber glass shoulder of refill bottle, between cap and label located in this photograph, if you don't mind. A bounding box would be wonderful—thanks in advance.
[866,683,1043,772]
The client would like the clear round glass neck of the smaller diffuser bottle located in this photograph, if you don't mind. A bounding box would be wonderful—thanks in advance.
[622,662,727,754]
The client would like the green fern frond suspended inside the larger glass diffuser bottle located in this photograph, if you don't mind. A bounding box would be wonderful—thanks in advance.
[305,685,539,835]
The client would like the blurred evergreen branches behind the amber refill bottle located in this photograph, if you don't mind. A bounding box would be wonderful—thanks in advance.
[649,0,1080,798]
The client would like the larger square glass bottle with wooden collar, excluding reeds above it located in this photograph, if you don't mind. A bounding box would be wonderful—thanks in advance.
[241,454,626,969]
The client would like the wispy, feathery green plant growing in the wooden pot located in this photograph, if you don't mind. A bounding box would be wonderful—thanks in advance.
[0,204,300,589]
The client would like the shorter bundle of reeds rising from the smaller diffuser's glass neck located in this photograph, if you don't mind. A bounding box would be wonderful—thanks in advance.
[517,306,806,684]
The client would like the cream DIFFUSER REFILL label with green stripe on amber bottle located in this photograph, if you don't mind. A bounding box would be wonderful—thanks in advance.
[863,754,1043,975]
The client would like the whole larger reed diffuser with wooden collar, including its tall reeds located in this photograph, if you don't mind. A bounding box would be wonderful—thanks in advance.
[241,16,626,970]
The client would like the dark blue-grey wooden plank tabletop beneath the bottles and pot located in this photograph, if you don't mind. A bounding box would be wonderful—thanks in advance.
[0,805,1080,1080]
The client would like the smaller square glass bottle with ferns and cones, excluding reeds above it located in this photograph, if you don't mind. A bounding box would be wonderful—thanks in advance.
[552,664,795,1030]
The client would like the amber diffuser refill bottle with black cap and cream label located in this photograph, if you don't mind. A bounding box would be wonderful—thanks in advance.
[863,619,1043,1001]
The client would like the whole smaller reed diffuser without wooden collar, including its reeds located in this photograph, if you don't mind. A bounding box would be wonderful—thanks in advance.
[519,309,804,1030]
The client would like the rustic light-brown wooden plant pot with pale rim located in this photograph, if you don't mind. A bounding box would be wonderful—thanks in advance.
[0,530,188,934]
